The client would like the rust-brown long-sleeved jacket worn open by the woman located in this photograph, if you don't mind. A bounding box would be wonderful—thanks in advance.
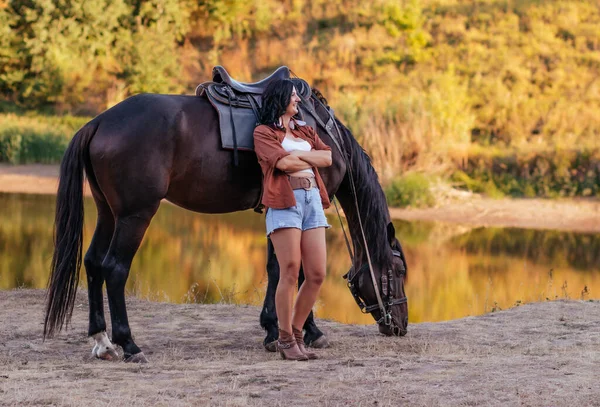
[254,120,331,209]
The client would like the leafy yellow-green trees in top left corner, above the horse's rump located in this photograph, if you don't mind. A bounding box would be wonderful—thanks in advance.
[0,0,190,111]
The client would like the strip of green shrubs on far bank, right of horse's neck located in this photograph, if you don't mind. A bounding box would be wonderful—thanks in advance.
[386,146,600,208]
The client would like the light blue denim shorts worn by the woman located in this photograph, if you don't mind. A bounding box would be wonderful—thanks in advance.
[266,188,331,236]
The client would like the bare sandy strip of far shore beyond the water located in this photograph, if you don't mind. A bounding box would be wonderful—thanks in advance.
[0,164,600,233]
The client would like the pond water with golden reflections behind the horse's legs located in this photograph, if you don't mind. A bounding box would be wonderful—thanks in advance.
[0,194,600,324]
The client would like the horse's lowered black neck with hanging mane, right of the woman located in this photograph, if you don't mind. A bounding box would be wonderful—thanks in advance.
[335,147,390,266]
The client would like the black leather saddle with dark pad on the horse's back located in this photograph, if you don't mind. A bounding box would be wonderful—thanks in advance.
[195,66,316,166]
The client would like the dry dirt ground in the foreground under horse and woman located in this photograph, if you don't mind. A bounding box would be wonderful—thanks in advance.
[0,290,600,407]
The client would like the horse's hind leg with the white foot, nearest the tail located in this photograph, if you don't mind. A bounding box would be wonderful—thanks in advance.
[84,198,118,360]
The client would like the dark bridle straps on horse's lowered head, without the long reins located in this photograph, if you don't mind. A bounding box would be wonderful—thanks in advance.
[344,249,408,326]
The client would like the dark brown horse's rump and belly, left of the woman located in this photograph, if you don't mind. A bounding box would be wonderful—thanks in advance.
[89,94,261,217]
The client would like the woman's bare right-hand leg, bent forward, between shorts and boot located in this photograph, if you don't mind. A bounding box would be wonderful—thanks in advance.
[292,228,327,330]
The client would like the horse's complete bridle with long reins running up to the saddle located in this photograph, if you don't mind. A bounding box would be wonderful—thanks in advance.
[290,78,408,326]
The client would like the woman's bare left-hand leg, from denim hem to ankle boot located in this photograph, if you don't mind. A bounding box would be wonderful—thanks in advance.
[270,228,308,334]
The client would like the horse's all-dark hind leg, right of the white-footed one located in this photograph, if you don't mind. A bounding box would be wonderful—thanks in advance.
[102,202,160,363]
